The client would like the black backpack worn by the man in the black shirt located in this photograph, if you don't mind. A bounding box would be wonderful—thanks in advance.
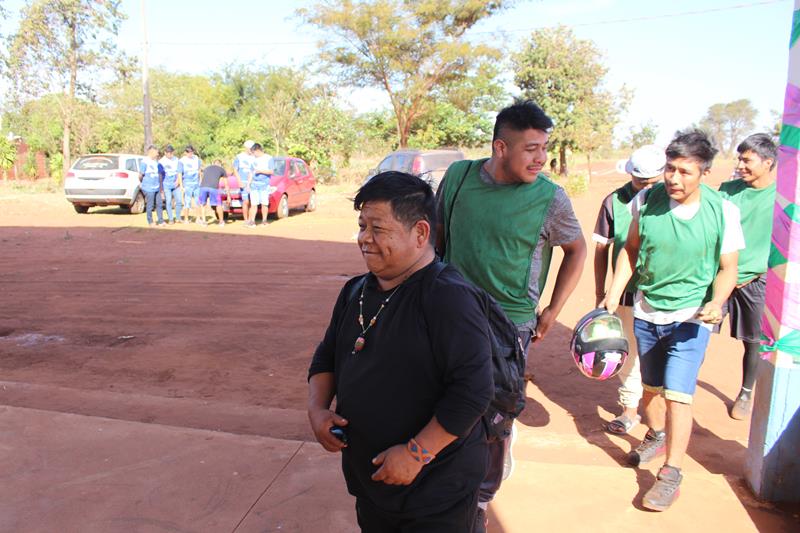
[348,261,525,441]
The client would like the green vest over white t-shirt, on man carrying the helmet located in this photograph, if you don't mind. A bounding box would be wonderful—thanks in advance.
[636,183,725,311]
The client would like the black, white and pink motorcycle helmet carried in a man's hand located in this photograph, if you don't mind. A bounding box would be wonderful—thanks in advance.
[570,309,628,381]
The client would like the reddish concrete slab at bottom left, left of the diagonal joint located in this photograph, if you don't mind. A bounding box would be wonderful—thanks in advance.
[0,407,301,533]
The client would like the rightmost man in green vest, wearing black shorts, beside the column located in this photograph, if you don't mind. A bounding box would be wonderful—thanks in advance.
[719,133,778,420]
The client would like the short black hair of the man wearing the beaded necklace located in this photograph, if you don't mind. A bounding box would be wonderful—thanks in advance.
[353,170,436,244]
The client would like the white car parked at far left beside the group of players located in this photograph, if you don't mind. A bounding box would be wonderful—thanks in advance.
[64,154,144,214]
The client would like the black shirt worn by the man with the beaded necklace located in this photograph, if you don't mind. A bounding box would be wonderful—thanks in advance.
[309,260,493,516]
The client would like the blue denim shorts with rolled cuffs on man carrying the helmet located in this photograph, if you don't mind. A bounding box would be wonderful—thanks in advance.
[633,318,711,404]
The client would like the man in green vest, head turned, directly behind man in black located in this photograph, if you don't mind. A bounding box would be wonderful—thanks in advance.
[437,101,586,532]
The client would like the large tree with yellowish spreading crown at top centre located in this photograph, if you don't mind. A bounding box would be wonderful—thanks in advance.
[298,0,509,148]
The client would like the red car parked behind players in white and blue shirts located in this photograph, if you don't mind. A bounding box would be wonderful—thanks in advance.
[219,157,317,218]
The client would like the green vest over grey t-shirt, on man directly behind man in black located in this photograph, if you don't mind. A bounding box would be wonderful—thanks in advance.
[443,159,556,324]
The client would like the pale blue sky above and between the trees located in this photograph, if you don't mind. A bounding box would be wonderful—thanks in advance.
[2,0,793,142]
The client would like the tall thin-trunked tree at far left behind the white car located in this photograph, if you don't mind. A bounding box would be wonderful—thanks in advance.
[6,0,124,172]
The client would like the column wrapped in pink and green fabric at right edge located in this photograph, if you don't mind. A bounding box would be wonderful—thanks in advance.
[746,0,800,502]
